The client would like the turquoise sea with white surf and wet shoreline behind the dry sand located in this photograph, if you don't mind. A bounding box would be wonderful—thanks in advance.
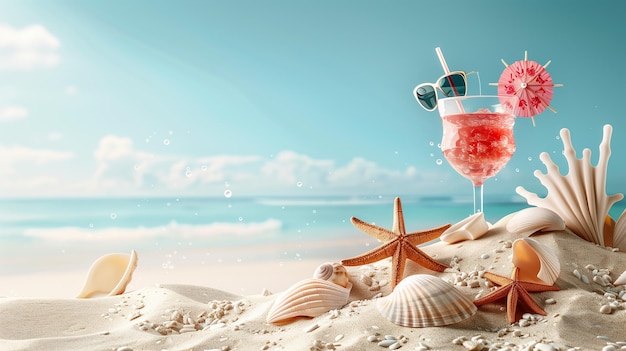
[0,196,624,276]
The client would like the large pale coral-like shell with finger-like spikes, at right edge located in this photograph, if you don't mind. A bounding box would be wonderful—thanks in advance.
[516,124,626,249]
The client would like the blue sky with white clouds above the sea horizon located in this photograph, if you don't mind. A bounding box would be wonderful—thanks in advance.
[0,0,626,199]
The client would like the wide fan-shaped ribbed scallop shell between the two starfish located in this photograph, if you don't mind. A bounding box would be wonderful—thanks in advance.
[376,274,476,328]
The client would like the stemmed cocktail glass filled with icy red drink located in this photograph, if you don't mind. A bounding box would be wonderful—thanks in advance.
[439,95,517,213]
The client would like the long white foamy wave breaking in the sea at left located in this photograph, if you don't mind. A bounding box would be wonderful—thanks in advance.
[24,219,283,241]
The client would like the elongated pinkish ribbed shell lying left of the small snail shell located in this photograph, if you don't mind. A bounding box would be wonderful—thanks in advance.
[266,278,352,324]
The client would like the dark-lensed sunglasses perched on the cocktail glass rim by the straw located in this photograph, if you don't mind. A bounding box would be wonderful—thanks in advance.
[413,71,478,111]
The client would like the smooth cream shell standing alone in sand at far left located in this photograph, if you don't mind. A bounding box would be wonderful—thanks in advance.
[76,250,138,298]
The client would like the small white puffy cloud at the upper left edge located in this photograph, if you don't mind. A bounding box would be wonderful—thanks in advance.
[0,24,61,70]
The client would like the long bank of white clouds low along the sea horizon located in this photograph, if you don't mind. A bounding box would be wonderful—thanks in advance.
[0,135,454,196]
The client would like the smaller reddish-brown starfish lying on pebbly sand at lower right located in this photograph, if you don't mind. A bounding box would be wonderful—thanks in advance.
[474,267,559,323]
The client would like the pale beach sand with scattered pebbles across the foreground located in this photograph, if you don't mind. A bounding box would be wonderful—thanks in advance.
[0,214,626,350]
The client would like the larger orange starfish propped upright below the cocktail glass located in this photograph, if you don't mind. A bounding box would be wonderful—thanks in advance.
[341,197,450,288]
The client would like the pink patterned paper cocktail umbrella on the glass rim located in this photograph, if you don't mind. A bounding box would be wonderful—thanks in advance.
[491,52,563,125]
